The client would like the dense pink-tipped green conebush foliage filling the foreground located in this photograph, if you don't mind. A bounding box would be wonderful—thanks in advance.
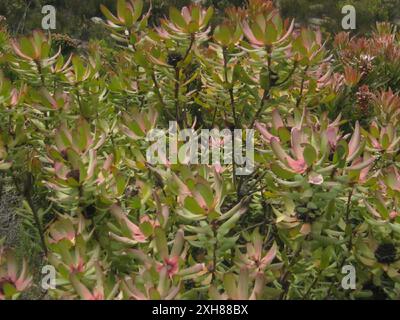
[0,0,400,299]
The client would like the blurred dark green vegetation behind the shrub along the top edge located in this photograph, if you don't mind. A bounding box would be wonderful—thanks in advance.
[0,0,400,41]
